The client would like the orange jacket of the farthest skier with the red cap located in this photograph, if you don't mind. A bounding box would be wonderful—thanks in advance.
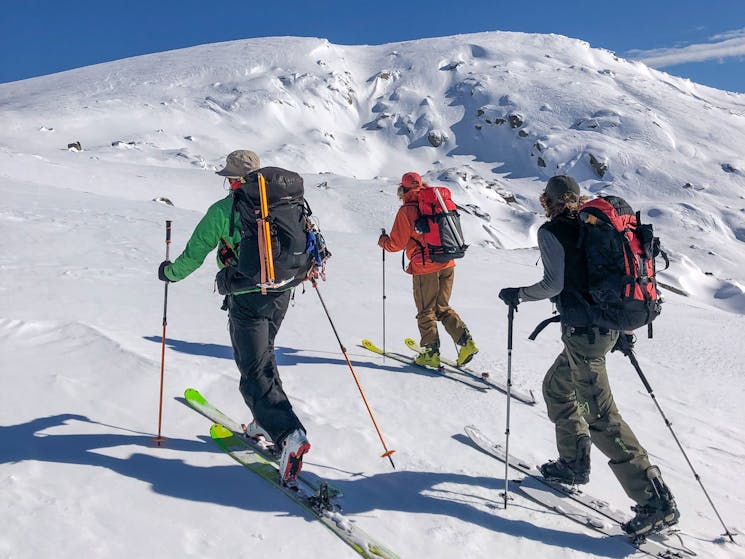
[378,188,455,276]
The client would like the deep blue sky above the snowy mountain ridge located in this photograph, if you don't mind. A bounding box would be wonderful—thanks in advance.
[0,0,745,93]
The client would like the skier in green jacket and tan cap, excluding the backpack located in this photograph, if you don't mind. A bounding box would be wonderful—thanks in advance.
[158,150,310,485]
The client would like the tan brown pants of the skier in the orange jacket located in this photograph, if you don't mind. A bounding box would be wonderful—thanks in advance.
[412,266,466,346]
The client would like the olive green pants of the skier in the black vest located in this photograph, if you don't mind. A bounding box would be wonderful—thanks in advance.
[543,327,653,504]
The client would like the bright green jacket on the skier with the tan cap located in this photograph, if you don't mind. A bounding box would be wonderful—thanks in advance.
[163,192,241,281]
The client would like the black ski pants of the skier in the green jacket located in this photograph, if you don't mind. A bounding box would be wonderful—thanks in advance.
[228,291,305,444]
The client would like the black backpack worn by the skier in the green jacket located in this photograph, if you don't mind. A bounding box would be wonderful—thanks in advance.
[217,167,331,295]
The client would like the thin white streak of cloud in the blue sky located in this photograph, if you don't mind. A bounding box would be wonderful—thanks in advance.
[628,28,745,68]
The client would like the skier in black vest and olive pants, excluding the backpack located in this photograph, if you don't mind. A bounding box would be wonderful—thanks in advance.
[499,175,680,535]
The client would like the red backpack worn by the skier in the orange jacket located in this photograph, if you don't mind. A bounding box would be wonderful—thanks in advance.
[414,186,468,262]
